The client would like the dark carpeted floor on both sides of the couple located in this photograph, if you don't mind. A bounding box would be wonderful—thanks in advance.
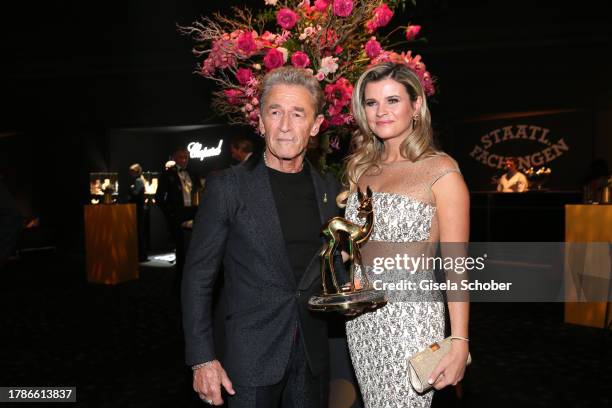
[0,253,612,408]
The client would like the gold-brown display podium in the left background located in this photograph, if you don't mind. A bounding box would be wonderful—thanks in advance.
[84,204,139,285]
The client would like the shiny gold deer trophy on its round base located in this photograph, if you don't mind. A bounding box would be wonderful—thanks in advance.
[308,187,387,313]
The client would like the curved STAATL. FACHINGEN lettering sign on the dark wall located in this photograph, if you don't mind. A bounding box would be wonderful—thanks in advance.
[470,125,569,169]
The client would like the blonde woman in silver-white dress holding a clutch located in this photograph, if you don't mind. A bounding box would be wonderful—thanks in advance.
[339,63,469,407]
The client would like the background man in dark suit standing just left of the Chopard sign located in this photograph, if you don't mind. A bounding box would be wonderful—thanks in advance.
[155,146,200,291]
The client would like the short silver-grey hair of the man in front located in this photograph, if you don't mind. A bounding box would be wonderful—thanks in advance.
[260,67,325,116]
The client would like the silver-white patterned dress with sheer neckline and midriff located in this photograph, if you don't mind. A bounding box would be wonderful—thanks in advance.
[346,154,459,408]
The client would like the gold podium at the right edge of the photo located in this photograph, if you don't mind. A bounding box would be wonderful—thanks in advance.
[565,204,612,328]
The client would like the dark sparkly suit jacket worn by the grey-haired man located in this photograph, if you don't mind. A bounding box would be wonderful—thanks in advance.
[182,155,343,386]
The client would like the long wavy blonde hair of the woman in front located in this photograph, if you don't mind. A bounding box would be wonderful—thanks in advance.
[338,62,438,202]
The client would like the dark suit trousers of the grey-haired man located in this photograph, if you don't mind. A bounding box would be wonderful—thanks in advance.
[224,332,329,408]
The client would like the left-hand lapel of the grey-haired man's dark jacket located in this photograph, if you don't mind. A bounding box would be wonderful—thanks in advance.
[239,155,297,287]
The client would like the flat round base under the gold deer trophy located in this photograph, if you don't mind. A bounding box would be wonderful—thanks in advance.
[308,289,387,312]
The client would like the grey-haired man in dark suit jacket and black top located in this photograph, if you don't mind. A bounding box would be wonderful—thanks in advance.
[182,67,341,408]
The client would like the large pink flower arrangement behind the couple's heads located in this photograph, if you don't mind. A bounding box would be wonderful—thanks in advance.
[179,0,435,156]
